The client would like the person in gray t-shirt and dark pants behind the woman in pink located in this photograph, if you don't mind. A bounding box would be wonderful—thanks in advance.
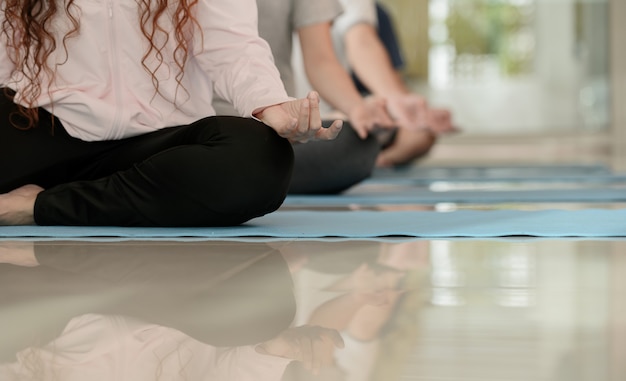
[213,0,394,194]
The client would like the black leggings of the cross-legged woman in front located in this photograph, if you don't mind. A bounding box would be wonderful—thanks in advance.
[0,89,293,226]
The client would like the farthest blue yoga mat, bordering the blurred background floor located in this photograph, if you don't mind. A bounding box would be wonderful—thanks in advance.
[365,165,626,185]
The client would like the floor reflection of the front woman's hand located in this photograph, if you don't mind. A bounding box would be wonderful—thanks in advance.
[256,325,344,373]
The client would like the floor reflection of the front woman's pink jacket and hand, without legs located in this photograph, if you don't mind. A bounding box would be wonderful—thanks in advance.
[0,314,343,381]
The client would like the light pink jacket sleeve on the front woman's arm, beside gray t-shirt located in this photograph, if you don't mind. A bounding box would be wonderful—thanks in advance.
[194,0,291,116]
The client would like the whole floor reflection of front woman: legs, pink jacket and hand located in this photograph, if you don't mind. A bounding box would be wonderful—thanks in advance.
[0,241,343,381]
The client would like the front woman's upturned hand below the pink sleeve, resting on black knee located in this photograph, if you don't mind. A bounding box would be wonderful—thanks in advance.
[255,92,343,143]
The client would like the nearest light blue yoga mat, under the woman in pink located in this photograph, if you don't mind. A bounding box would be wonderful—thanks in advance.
[0,209,626,239]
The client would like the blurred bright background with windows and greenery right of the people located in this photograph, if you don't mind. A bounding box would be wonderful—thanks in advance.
[372,0,626,171]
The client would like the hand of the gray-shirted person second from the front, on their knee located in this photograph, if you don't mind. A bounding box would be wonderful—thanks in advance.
[348,97,396,139]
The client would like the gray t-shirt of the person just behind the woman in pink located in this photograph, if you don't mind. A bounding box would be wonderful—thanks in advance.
[213,0,343,115]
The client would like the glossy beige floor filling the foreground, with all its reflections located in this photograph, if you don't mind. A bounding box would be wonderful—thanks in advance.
[0,239,626,381]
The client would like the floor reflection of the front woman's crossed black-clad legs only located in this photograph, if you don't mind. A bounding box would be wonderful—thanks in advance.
[0,241,296,360]
